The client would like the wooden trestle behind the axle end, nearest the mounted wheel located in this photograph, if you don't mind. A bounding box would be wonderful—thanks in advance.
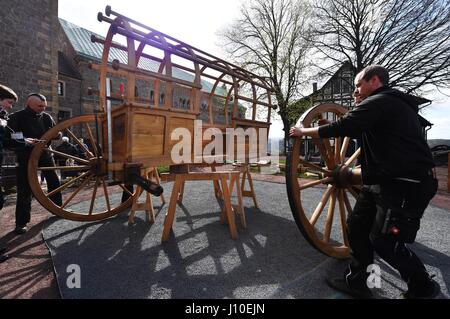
[128,167,166,224]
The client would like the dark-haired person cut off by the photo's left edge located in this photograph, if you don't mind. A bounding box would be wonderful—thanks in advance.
[0,84,18,263]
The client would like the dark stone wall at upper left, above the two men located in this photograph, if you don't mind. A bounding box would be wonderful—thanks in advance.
[0,0,59,115]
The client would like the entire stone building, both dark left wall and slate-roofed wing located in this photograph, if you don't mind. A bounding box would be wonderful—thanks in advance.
[0,0,246,189]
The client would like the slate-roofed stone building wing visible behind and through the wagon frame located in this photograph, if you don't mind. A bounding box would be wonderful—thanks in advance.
[58,19,241,123]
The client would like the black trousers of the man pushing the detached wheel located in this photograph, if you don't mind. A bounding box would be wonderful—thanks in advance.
[347,176,437,285]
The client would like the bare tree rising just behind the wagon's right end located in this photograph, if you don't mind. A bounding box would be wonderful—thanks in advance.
[219,0,310,154]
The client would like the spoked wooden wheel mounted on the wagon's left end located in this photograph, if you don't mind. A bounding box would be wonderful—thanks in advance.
[28,115,134,221]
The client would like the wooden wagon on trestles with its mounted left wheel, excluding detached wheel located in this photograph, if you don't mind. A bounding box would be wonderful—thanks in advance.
[28,6,276,230]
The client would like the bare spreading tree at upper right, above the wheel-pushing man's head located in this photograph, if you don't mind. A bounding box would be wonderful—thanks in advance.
[313,0,450,93]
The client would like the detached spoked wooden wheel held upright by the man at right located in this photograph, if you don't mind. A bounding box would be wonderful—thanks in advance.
[286,104,362,258]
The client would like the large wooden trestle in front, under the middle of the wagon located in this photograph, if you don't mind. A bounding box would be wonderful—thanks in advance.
[161,169,246,242]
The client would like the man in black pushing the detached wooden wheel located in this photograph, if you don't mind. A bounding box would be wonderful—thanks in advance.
[290,65,439,298]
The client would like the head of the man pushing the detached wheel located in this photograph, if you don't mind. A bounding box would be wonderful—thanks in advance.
[354,65,389,101]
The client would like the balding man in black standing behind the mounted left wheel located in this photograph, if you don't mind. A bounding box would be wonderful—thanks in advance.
[8,93,62,234]
